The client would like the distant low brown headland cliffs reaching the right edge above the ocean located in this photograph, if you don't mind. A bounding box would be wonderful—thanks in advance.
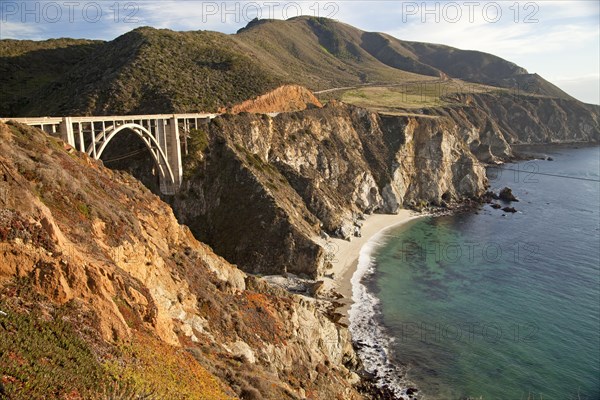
[426,93,600,162]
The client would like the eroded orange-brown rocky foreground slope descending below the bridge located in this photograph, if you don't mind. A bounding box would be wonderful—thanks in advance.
[0,124,360,399]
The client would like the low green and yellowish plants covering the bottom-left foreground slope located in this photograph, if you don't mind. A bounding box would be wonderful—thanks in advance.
[0,278,232,400]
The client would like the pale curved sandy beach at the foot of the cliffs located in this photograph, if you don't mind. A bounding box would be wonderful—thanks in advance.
[323,210,423,322]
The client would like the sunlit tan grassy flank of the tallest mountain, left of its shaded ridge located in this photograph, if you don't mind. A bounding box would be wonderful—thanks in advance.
[234,17,433,90]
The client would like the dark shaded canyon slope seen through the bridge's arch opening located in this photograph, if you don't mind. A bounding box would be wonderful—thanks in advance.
[100,129,161,196]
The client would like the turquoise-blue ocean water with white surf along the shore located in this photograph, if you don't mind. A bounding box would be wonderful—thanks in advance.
[351,147,600,400]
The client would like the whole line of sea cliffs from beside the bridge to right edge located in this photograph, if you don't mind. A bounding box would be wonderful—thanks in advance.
[168,88,600,279]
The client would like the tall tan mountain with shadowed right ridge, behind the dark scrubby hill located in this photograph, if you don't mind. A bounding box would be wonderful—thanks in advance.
[236,17,572,99]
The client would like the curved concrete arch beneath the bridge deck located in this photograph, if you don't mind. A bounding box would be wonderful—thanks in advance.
[86,122,177,189]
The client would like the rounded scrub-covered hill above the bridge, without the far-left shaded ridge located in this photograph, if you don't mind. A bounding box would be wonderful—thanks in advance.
[0,28,279,115]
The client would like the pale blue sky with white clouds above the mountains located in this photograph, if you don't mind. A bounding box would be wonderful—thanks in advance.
[0,0,600,104]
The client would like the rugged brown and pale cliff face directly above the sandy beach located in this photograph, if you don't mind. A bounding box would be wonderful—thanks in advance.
[172,104,486,277]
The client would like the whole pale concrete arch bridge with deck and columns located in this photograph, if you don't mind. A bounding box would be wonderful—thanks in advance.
[0,114,219,194]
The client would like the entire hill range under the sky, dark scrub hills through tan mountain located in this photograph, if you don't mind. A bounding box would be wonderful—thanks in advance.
[0,17,584,116]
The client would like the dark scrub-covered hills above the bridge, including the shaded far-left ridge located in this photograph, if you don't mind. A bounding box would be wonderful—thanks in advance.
[0,27,281,115]
